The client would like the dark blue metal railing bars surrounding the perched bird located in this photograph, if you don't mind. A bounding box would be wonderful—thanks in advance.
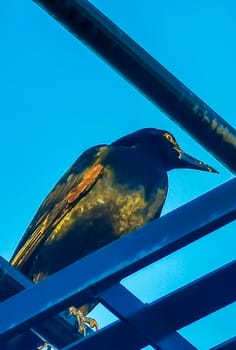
[0,0,236,350]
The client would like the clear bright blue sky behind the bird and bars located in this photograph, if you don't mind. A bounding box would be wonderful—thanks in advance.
[0,0,236,350]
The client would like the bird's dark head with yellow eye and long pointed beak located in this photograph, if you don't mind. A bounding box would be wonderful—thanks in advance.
[113,128,218,173]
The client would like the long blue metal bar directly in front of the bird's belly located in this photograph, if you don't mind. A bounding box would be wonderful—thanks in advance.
[0,178,236,339]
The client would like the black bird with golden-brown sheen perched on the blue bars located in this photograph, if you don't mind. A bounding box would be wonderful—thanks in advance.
[11,128,217,331]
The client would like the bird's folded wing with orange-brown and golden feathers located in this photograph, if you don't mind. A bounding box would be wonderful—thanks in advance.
[11,145,109,268]
